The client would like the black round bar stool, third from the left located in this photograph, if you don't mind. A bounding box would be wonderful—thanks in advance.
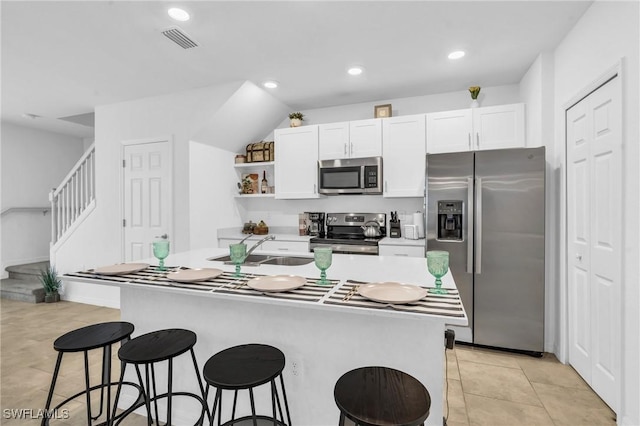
[203,344,291,426]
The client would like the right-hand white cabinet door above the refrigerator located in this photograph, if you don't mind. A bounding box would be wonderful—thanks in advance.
[473,104,525,150]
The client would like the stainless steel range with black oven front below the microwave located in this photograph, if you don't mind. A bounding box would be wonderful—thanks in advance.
[309,213,387,255]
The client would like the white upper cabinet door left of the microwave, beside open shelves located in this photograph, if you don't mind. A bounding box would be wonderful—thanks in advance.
[274,126,320,199]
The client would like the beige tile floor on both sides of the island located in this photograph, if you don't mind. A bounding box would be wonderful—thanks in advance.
[0,299,616,426]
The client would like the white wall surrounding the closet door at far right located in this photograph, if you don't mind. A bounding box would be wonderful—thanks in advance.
[554,1,640,425]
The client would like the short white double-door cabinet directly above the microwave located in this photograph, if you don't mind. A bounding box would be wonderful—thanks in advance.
[319,118,382,160]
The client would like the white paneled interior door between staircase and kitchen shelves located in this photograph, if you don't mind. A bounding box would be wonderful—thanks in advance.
[123,141,173,261]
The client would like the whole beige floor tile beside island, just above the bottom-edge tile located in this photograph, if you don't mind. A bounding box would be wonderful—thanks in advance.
[458,360,542,406]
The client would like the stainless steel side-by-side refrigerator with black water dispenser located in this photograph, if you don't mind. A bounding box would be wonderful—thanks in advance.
[425,147,545,352]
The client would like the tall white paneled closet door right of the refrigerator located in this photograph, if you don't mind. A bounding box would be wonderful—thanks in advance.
[567,77,624,411]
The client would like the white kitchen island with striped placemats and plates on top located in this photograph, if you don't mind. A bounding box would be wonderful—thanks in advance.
[65,248,467,426]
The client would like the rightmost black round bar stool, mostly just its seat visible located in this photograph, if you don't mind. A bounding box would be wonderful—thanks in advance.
[333,367,431,426]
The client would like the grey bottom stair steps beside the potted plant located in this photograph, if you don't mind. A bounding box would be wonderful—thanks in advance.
[0,262,49,303]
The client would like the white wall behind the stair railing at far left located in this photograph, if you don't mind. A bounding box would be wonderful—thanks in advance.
[0,123,84,277]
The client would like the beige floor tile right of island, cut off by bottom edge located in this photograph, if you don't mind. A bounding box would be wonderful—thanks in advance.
[465,394,553,426]
